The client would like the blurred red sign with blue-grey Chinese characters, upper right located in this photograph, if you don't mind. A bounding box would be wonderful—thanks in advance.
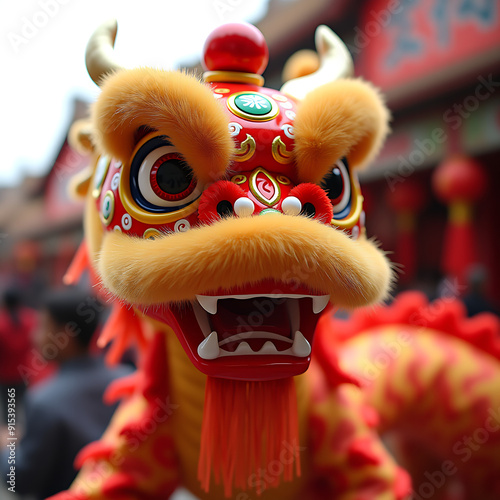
[358,0,500,99]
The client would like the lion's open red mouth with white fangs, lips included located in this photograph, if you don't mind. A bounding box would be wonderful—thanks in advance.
[145,282,330,380]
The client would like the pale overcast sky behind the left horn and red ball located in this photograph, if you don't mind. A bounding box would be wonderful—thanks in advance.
[0,0,267,186]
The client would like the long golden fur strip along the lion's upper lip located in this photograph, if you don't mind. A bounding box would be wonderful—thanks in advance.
[98,215,391,308]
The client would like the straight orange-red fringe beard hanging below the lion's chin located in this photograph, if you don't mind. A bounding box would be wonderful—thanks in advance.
[198,377,301,498]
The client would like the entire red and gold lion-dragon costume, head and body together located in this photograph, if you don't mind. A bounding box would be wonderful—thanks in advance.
[51,23,500,500]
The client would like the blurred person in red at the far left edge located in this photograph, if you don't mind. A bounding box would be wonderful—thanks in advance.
[0,286,37,425]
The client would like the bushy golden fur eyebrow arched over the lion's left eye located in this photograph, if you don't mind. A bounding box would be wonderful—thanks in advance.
[92,68,234,183]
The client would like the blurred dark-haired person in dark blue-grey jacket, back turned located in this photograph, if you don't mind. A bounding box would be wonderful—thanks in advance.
[0,287,131,499]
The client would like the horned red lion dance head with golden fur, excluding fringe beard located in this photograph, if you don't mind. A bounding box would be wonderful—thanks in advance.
[68,22,391,496]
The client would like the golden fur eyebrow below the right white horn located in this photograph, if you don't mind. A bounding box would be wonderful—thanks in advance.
[294,79,389,184]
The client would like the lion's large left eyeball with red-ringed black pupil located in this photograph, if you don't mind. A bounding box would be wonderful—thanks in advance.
[131,136,201,211]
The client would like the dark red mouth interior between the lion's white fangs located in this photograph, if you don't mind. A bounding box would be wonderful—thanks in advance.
[210,297,292,352]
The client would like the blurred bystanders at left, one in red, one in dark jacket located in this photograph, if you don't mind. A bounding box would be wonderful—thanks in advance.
[0,286,133,499]
